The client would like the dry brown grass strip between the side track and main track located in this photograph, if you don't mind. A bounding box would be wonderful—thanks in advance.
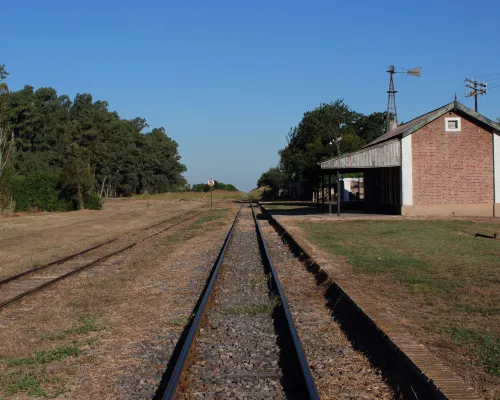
[0,204,236,399]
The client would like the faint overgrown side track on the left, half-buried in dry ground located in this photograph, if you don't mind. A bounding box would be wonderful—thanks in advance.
[0,211,205,309]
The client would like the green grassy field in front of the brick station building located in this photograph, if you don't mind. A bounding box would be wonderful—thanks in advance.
[296,220,500,390]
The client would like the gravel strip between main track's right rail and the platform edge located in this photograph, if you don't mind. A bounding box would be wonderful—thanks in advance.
[260,214,395,400]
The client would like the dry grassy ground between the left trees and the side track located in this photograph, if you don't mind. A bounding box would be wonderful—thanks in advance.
[0,199,217,278]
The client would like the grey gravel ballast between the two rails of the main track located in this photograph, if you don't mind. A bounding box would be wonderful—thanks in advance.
[178,207,291,399]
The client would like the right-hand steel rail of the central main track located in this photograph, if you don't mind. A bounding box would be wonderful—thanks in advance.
[250,203,320,400]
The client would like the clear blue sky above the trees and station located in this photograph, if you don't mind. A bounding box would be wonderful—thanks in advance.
[0,0,500,190]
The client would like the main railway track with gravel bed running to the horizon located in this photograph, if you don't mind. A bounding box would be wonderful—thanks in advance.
[163,204,319,400]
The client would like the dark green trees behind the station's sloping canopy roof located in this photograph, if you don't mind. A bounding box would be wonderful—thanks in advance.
[257,99,386,195]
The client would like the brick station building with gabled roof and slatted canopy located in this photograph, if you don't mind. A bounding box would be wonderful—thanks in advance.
[320,101,500,217]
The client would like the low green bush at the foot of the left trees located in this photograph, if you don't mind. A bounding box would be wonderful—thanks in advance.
[12,172,72,211]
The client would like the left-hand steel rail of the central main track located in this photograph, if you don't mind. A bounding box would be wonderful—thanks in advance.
[162,207,241,400]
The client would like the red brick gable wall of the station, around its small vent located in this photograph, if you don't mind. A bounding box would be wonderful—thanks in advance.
[411,113,493,205]
